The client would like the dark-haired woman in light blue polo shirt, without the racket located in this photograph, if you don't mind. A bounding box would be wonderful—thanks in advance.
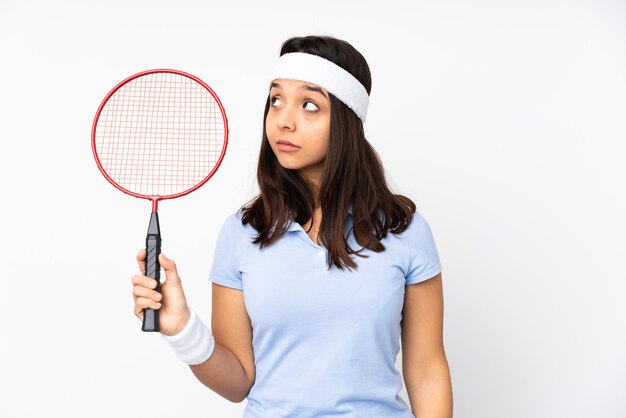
[132,36,452,418]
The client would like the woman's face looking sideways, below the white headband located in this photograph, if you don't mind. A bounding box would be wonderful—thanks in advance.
[265,78,330,185]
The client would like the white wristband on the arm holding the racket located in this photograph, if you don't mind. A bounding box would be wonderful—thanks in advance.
[161,308,215,365]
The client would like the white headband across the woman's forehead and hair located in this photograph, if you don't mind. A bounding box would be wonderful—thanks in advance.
[271,52,369,122]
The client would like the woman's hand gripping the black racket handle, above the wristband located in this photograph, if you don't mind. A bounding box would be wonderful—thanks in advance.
[131,250,190,335]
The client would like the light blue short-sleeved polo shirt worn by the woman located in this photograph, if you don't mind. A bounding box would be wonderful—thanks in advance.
[209,210,441,418]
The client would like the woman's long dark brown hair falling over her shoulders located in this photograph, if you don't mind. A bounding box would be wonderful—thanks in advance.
[240,36,416,269]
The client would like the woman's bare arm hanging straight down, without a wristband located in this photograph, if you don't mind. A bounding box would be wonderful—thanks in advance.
[400,273,452,418]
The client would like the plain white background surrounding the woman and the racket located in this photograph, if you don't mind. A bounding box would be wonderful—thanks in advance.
[0,0,626,418]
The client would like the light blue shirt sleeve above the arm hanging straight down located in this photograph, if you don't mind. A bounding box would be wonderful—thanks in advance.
[406,212,441,285]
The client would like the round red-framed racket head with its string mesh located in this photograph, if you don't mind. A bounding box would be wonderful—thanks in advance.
[91,69,228,206]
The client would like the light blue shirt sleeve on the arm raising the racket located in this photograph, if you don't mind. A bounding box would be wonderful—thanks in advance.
[209,214,243,290]
